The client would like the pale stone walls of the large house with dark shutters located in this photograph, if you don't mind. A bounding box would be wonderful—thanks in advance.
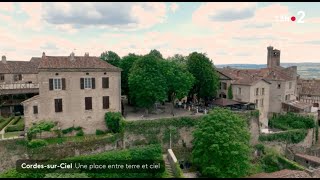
[23,52,121,134]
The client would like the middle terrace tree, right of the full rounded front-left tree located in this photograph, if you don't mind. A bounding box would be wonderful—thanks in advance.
[160,61,195,114]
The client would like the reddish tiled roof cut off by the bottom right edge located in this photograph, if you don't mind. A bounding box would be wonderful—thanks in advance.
[249,169,311,178]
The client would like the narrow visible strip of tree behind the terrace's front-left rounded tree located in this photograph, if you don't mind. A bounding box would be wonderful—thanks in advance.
[119,53,141,104]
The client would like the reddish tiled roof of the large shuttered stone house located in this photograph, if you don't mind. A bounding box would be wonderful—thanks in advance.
[39,56,121,71]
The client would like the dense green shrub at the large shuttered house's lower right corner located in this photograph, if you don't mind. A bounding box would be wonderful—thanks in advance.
[105,112,124,133]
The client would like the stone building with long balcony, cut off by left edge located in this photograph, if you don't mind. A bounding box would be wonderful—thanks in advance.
[0,56,40,117]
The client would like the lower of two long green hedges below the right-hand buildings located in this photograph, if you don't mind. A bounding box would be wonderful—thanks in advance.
[259,129,308,143]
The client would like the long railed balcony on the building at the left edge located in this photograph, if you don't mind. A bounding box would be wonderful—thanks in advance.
[0,83,39,95]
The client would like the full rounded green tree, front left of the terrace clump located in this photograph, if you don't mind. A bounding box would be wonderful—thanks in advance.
[128,54,168,114]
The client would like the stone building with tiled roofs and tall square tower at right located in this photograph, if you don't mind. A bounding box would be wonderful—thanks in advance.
[217,46,298,126]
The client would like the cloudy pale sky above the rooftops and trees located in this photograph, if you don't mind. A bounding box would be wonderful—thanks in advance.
[0,2,320,64]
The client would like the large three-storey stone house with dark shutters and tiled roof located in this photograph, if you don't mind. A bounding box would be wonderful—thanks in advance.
[22,53,121,134]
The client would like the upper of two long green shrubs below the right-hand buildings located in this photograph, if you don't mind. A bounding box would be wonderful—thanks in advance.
[269,113,315,130]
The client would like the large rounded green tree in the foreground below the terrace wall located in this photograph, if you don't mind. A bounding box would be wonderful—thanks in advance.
[192,108,251,178]
